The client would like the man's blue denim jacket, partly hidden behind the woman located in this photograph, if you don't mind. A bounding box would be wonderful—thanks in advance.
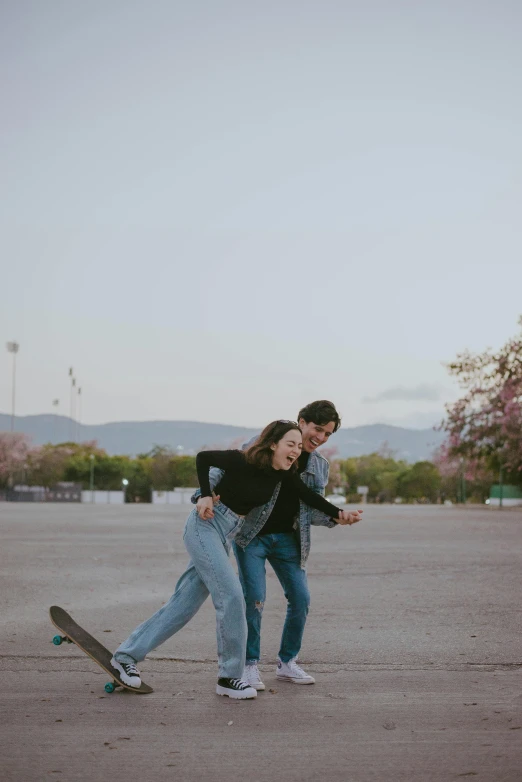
[191,438,337,570]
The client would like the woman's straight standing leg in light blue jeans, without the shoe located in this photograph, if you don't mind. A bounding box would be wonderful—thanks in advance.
[185,506,247,679]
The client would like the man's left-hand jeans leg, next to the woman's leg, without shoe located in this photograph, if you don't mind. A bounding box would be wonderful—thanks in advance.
[234,535,270,665]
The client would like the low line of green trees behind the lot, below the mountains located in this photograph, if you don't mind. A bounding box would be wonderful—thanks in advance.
[0,433,491,502]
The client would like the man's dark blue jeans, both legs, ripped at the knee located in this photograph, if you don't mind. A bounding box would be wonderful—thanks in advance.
[234,533,310,665]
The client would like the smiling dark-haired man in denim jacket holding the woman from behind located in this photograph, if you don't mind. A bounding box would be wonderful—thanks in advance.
[195,400,362,690]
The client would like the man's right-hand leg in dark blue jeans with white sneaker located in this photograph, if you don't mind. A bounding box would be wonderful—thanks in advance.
[268,533,314,684]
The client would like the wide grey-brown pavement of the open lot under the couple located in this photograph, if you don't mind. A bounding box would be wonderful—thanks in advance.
[0,503,522,782]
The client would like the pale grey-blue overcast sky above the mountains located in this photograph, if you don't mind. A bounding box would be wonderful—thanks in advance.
[0,0,522,426]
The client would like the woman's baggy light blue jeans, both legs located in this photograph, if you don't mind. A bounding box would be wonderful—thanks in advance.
[114,502,247,679]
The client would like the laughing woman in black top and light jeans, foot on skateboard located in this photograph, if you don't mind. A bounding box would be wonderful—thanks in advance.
[112,421,352,699]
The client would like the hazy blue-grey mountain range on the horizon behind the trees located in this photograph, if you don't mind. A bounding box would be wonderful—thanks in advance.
[0,413,444,462]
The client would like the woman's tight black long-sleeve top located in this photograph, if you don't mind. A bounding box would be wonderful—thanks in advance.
[196,451,340,519]
